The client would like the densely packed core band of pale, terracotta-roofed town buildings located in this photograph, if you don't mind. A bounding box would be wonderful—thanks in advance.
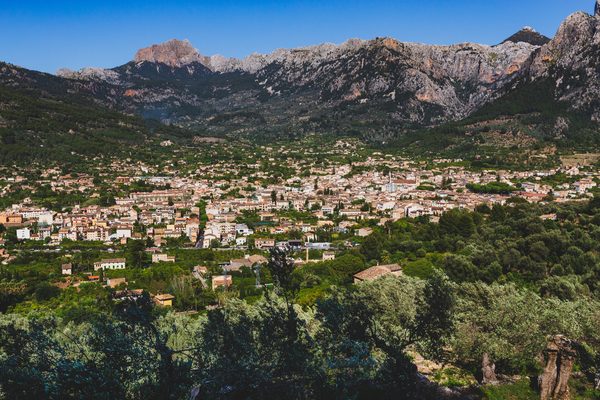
[0,160,598,249]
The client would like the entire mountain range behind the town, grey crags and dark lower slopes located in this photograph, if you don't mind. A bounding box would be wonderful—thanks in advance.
[0,1,600,152]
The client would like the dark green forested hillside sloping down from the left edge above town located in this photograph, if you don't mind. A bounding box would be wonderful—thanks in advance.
[0,64,220,166]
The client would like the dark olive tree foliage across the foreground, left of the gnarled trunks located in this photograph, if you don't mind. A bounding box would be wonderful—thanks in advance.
[0,270,454,399]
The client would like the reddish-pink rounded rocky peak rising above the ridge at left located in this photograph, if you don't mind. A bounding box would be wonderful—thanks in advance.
[133,39,210,67]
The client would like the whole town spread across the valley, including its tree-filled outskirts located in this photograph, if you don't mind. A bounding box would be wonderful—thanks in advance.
[0,139,600,308]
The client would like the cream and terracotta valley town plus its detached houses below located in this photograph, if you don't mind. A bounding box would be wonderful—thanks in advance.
[0,150,598,294]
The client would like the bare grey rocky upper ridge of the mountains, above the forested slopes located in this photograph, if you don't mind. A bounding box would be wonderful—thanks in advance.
[51,0,600,132]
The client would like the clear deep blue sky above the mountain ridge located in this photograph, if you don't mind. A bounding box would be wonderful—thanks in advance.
[0,0,594,73]
